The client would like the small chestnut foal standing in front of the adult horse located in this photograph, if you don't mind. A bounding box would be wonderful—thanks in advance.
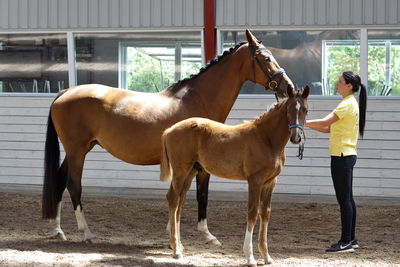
[160,86,310,265]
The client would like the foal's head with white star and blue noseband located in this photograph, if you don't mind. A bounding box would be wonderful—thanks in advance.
[287,86,310,144]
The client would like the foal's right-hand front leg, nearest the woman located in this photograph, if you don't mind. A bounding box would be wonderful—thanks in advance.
[258,178,276,264]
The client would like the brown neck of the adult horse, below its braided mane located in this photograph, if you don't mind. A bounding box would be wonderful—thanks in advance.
[182,45,250,122]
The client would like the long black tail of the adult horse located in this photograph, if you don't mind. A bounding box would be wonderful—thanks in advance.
[42,93,65,219]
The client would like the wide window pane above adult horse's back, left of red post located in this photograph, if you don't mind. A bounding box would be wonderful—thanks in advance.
[75,31,202,92]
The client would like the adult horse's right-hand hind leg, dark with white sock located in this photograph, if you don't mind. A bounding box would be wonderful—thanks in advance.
[67,153,94,243]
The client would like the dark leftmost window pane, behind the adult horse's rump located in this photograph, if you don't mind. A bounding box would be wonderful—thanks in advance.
[0,34,68,93]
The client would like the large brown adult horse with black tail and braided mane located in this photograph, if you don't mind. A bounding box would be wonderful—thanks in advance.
[42,31,293,244]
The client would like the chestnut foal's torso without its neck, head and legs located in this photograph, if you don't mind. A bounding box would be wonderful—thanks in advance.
[163,118,271,180]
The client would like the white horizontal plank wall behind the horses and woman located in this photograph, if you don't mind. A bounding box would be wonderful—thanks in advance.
[0,96,400,197]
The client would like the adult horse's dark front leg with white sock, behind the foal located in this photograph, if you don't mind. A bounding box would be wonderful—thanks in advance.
[196,170,221,246]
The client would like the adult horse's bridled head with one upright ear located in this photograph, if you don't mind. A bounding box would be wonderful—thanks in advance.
[246,30,294,97]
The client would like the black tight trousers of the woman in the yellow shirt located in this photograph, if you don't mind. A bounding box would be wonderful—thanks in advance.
[331,155,357,243]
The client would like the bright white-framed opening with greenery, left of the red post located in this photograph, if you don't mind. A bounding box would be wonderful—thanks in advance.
[119,41,202,92]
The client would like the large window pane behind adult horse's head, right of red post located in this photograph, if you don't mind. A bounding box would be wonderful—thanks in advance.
[221,30,360,95]
